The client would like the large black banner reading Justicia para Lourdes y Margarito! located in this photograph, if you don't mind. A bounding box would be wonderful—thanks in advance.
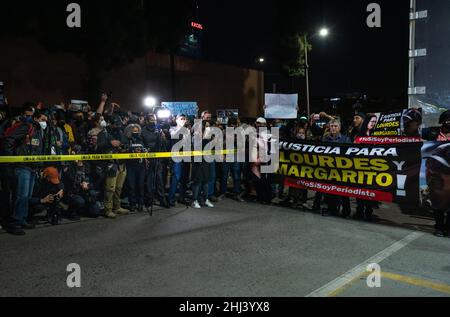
[277,142,422,204]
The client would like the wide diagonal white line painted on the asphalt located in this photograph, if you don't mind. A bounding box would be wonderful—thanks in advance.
[306,232,424,297]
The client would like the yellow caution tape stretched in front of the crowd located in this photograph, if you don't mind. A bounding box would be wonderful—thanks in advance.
[0,150,236,164]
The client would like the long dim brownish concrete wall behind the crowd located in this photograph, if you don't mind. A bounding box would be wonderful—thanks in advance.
[0,39,264,117]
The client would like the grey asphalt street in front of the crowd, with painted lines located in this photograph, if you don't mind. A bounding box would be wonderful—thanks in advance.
[0,200,450,297]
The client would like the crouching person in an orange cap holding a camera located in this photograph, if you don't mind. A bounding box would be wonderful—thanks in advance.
[30,167,64,225]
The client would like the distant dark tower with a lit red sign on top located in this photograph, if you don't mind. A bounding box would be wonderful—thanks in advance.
[180,0,204,58]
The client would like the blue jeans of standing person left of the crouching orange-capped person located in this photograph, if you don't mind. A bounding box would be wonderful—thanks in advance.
[12,167,36,226]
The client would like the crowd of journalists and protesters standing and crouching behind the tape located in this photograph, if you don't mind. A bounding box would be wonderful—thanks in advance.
[0,94,442,235]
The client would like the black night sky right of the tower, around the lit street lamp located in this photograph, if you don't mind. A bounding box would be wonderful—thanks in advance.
[199,0,409,98]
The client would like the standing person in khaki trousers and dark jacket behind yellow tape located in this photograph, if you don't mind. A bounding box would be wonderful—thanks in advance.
[97,115,129,219]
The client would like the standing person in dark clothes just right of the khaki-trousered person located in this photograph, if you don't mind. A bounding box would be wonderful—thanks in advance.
[125,124,147,212]
